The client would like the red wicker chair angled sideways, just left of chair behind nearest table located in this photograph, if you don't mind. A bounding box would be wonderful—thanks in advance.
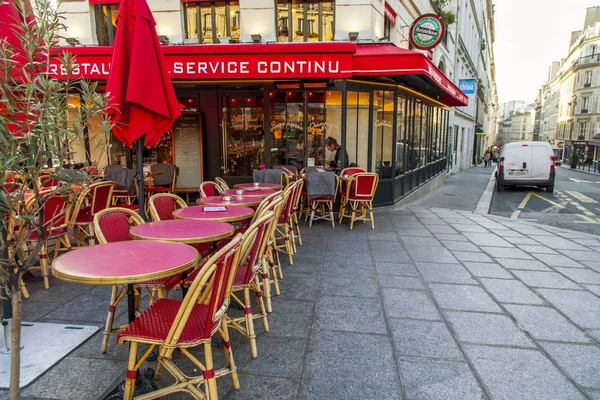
[70,181,115,246]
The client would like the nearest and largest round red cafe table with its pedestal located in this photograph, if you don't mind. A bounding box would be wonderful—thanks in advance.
[52,240,199,322]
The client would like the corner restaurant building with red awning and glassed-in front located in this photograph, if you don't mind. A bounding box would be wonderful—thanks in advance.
[55,0,495,205]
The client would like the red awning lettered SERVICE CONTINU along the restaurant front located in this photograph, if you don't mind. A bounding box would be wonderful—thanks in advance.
[50,42,468,106]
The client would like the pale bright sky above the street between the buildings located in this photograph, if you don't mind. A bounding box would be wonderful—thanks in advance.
[494,0,600,104]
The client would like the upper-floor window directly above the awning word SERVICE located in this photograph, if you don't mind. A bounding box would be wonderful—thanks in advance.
[183,0,240,43]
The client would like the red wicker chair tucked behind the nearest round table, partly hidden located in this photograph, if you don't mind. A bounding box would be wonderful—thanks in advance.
[94,207,181,353]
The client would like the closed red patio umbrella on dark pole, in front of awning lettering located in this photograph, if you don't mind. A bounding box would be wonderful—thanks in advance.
[106,0,181,216]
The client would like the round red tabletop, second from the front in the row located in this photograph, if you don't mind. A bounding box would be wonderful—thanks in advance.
[129,219,234,244]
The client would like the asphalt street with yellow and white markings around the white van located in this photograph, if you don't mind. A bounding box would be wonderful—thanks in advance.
[490,167,600,235]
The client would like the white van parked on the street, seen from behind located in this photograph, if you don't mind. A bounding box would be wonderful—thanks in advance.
[496,142,555,192]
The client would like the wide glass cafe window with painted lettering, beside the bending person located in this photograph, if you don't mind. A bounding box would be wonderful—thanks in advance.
[269,90,342,169]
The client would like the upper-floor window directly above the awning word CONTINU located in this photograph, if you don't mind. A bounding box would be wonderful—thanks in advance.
[276,0,335,42]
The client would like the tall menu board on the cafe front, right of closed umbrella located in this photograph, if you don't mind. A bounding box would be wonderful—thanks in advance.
[173,115,202,189]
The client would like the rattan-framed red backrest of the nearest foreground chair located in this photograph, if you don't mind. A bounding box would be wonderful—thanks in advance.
[161,234,242,346]
